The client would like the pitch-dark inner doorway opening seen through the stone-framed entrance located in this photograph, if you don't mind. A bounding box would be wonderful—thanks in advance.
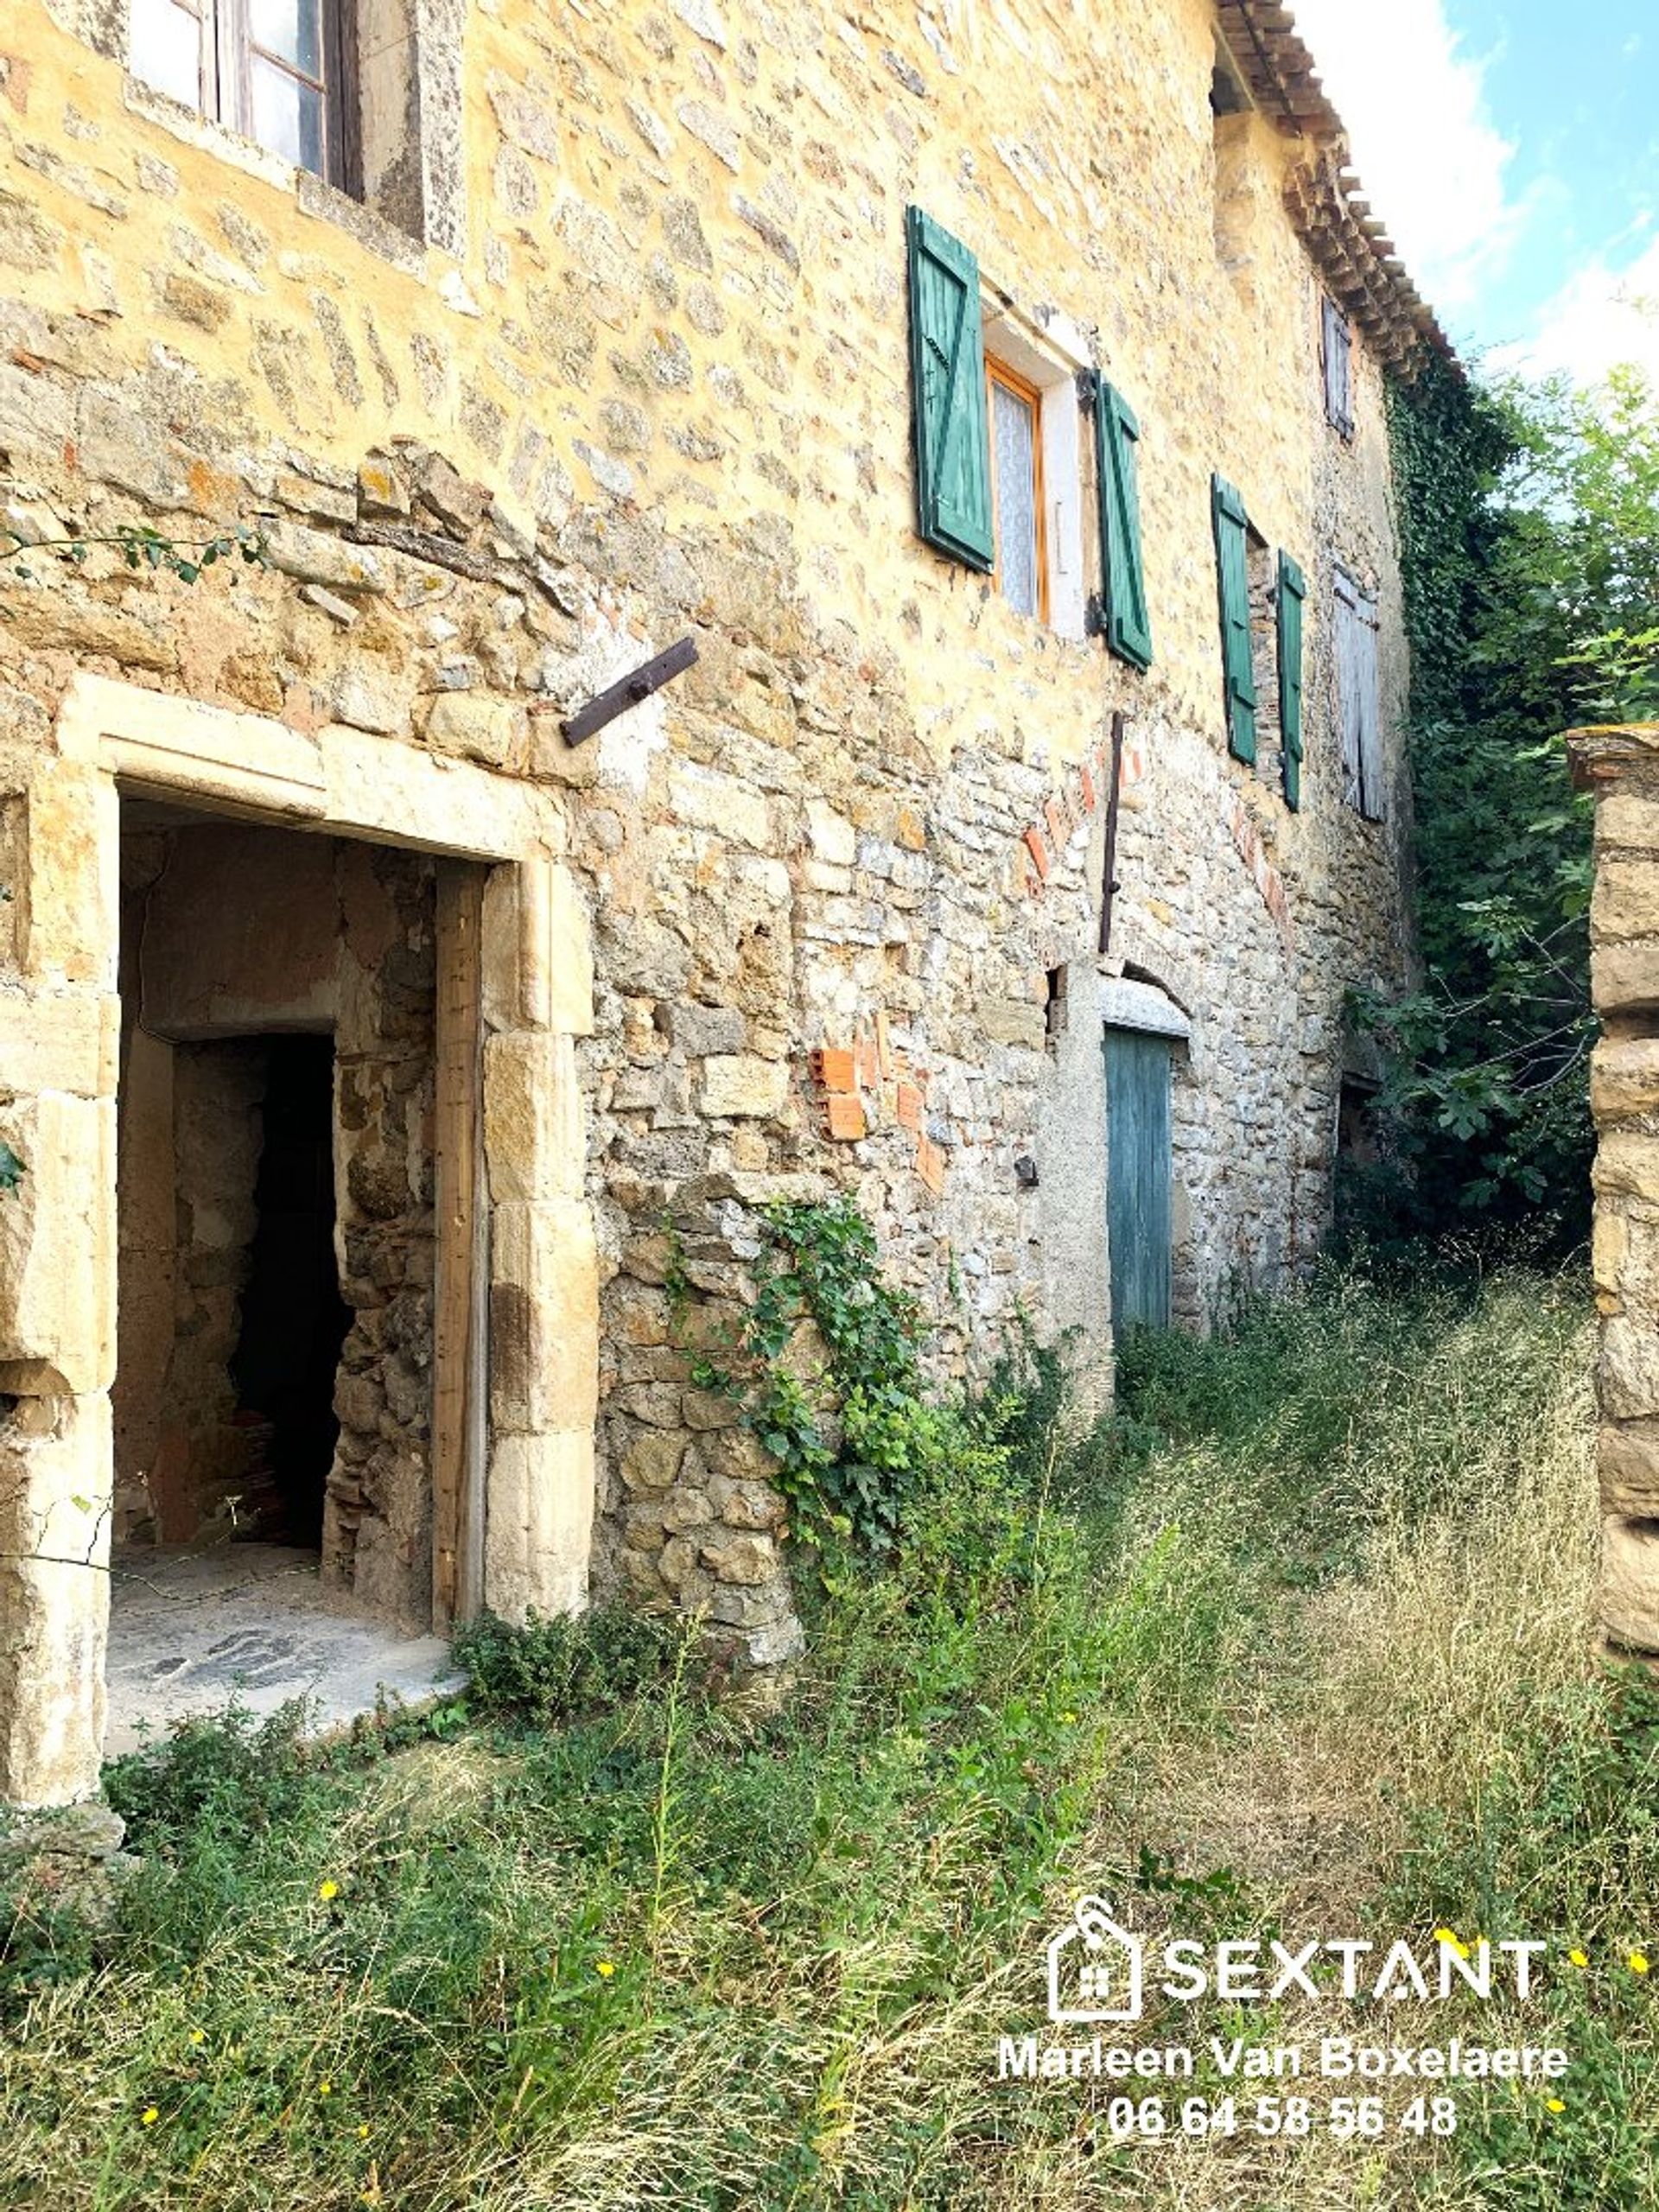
[230,1038,352,1546]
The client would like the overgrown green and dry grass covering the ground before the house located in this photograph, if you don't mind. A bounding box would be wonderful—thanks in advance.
[0,1276,1659,2212]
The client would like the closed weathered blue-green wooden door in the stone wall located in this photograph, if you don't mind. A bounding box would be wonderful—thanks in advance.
[1103,1028,1170,1336]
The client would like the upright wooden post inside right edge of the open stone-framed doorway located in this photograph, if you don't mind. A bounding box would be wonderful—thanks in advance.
[431,862,489,1628]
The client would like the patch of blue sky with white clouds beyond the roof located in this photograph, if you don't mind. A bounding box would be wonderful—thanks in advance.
[1292,0,1659,383]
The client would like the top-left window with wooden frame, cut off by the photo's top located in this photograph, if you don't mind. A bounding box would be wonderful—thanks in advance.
[130,0,363,197]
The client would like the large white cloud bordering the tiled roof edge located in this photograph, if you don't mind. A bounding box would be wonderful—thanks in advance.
[1294,0,1529,323]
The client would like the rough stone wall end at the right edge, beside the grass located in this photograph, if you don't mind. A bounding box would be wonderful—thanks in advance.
[1571,723,1659,1655]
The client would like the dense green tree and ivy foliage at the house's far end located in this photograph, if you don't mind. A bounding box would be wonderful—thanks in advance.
[1347,349,1659,1245]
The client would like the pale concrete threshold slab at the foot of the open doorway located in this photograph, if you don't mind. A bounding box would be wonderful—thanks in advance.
[104,1544,467,1758]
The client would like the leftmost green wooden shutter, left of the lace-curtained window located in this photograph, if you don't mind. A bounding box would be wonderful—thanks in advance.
[905,208,995,569]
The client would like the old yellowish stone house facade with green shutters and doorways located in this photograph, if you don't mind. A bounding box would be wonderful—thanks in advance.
[0,0,1445,1798]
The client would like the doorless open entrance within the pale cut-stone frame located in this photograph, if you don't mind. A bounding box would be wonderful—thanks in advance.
[108,801,455,1743]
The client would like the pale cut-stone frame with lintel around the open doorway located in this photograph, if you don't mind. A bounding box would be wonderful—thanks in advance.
[0,672,597,1805]
